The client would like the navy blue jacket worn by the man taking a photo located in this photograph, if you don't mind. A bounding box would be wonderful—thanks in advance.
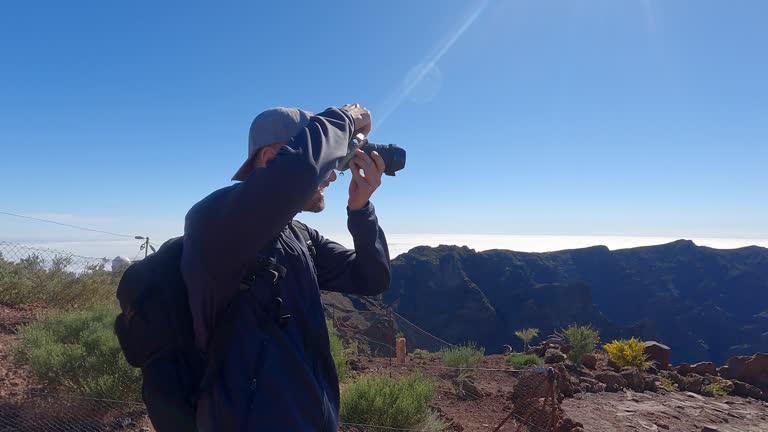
[181,108,390,432]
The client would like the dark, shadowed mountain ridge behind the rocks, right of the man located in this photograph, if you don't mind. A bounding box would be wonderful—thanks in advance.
[383,239,768,363]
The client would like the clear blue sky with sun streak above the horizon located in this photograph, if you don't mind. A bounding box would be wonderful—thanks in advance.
[0,0,768,256]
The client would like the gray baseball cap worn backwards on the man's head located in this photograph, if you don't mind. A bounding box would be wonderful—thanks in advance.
[232,107,314,181]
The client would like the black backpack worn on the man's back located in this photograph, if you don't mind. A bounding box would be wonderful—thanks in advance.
[114,221,315,432]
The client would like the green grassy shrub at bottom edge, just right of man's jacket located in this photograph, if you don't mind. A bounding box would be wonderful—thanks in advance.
[339,373,443,431]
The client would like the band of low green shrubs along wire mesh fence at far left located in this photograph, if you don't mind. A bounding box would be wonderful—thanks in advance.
[0,255,122,310]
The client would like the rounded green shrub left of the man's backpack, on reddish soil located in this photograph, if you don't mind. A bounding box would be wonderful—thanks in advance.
[15,306,141,400]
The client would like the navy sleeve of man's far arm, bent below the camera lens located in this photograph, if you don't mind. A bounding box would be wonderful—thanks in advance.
[310,202,391,296]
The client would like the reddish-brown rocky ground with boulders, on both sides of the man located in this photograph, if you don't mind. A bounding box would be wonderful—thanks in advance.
[0,306,768,432]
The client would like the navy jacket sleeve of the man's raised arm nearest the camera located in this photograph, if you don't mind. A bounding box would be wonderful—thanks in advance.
[182,108,354,282]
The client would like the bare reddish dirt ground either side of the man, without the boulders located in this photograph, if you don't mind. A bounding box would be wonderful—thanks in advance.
[0,306,768,432]
